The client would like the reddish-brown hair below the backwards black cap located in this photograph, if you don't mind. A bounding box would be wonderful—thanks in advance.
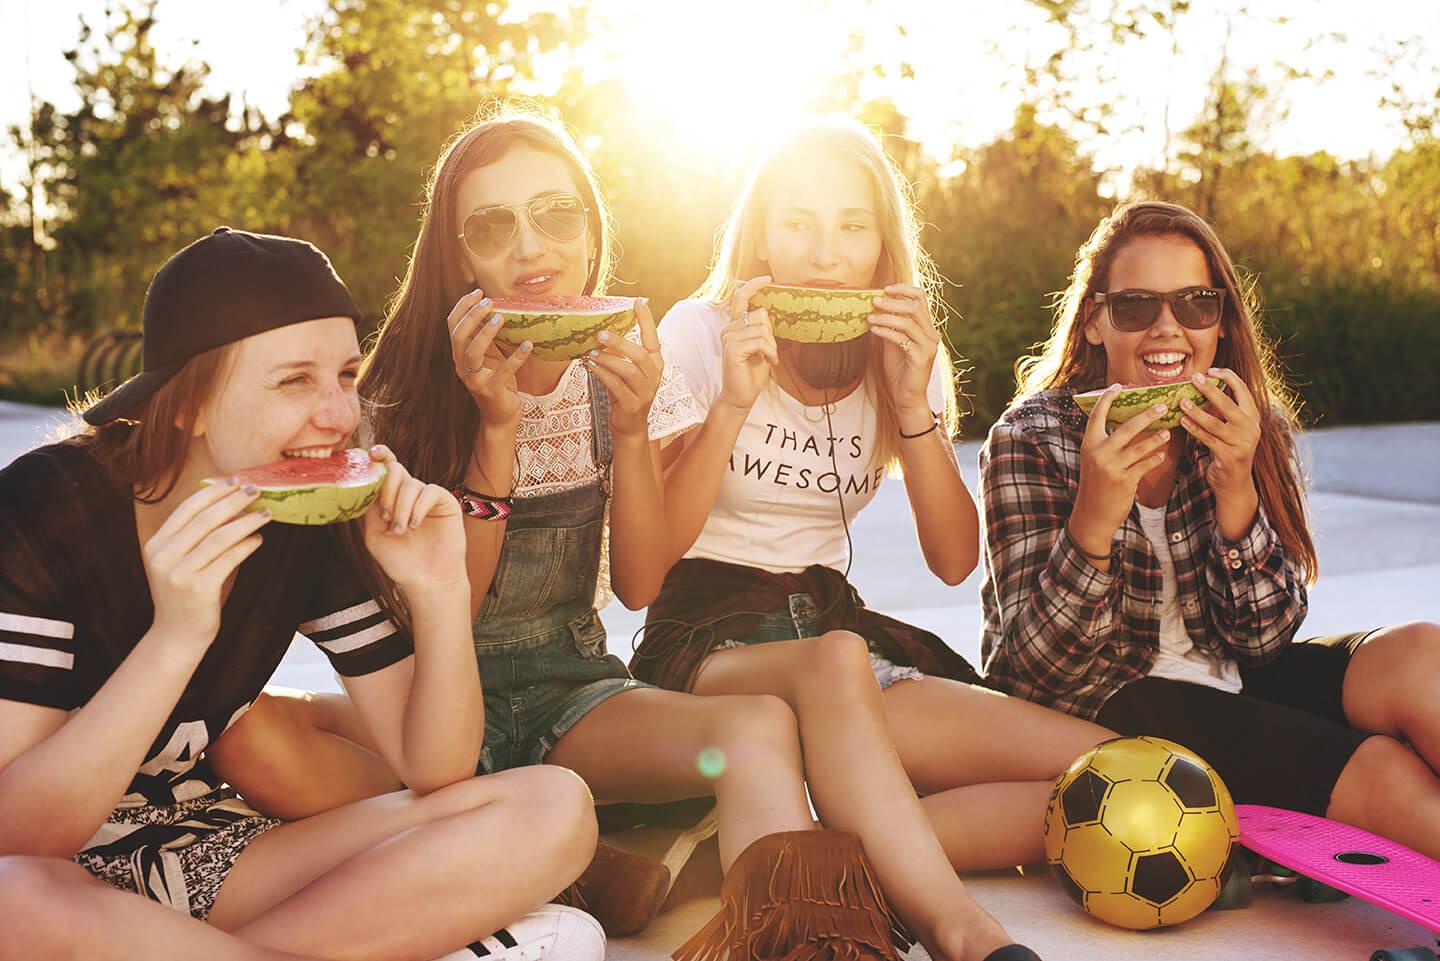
[66,344,235,504]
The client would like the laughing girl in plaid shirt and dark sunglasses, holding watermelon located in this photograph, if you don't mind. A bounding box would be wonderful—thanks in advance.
[981,203,1440,857]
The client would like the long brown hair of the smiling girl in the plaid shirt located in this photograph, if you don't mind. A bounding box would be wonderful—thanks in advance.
[1015,200,1319,582]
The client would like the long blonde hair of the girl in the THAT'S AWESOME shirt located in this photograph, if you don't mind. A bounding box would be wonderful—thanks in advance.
[694,118,959,474]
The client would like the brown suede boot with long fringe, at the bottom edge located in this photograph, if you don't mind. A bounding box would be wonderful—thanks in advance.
[672,830,910,961]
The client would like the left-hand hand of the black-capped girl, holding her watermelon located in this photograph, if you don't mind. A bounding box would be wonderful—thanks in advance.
[141,477,271,647]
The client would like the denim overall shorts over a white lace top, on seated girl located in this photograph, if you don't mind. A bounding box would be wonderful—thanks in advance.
[471,375,649,774]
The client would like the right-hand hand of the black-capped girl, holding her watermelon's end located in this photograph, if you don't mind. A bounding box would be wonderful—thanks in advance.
[364,444,468,596]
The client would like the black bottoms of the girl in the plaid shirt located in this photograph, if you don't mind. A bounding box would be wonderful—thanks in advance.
[1096,631,1374,815]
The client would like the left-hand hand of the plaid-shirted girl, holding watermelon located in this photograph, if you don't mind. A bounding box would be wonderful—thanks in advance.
[1068,383,1169,555]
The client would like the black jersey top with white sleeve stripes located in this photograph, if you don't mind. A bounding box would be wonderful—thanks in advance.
[0,442,413,808]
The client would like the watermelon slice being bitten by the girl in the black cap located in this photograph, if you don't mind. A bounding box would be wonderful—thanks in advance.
[202,448,386,524]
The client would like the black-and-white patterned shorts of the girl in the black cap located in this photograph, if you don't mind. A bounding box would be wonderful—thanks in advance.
[75,788,281,921]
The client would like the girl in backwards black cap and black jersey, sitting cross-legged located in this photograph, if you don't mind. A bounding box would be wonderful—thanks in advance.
[0,229,603,961]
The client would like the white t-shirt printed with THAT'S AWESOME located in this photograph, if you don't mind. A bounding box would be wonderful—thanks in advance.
[660,300,946,573]
